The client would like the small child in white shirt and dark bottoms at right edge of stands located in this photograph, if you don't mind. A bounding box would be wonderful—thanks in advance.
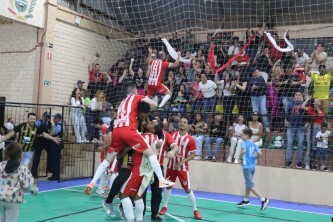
[313,122,332,171]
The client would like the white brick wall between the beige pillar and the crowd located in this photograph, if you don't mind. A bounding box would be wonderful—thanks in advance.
[51,21,128,104]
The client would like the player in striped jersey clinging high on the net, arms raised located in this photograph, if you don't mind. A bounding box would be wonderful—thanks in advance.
[147,48,181,108]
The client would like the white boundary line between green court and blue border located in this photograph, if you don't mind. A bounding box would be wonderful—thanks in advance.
[25,185,332,217]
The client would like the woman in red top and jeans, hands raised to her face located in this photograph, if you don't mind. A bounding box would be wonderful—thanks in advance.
[301,96,325,170]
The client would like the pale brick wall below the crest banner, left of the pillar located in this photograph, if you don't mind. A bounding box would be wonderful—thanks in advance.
[0,22,37,102]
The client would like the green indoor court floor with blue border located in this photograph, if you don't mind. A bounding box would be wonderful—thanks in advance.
[19,180,332,222]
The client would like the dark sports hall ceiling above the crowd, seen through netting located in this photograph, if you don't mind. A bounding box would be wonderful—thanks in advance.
[68,0,333,33]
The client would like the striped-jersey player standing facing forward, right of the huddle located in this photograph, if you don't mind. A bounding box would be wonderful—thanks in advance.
[159,117,202,220]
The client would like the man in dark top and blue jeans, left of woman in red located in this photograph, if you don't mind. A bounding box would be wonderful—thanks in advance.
[285,91,306,169]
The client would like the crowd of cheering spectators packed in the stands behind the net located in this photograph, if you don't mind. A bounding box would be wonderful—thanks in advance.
[71,27,332,169]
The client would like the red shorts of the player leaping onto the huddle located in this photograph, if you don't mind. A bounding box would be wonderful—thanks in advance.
[108,127,150,153]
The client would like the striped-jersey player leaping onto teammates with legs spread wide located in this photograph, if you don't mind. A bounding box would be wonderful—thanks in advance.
[84,83,174,195]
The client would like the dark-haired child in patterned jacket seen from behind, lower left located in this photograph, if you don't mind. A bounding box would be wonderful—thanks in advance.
[0,142,38,222]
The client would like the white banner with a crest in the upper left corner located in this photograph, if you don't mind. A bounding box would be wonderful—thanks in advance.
[0,0,45,28]
